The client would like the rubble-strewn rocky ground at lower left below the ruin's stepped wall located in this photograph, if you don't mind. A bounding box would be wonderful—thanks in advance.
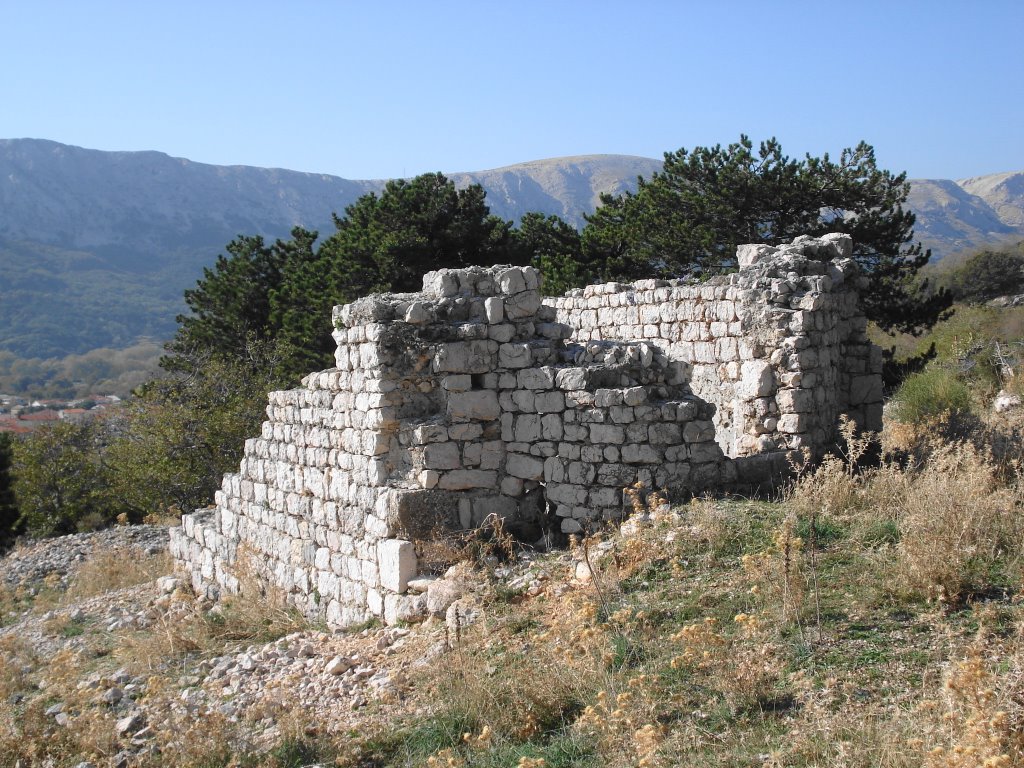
[0,526,577,768]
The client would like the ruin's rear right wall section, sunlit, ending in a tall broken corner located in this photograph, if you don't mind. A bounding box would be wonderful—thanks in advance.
[546,234,882,466]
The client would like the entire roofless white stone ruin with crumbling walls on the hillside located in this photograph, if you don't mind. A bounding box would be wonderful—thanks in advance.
[171,236,882,627]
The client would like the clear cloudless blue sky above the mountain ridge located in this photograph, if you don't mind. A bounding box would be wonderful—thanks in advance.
[0,0,1024,178]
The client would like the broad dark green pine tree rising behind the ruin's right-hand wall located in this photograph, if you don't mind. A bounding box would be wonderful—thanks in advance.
[583,136,951,333]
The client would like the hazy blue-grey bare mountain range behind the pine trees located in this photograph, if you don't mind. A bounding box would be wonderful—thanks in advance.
[0,139,1024,357]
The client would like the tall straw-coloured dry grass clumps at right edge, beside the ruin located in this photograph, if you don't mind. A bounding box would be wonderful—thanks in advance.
[788,421,1024,603]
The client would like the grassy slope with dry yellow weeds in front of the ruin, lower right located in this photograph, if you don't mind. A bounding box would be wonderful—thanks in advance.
[346,421,1024,768]
